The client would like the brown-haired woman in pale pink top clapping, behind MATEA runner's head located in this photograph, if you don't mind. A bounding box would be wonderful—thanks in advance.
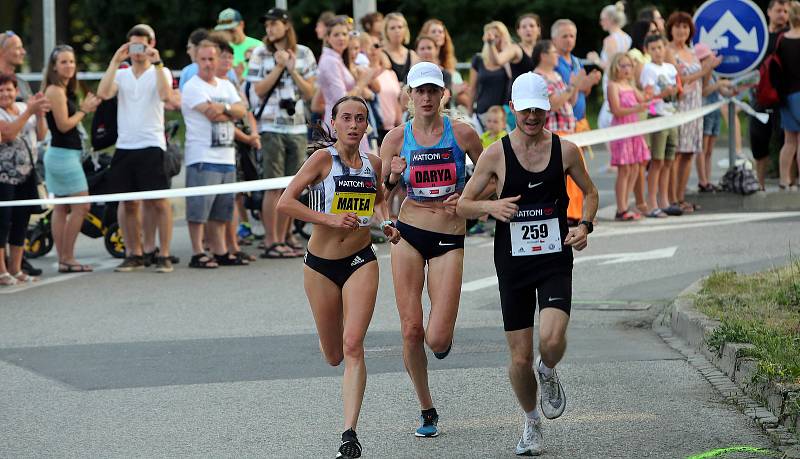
[317,16,371,152]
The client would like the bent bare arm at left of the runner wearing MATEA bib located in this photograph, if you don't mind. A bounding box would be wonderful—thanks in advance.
[277,149,358,229]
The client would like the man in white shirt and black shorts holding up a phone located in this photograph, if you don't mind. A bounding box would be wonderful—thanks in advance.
[97,24,173,273]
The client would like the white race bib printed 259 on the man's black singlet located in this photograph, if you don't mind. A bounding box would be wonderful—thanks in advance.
[508,204,562,257]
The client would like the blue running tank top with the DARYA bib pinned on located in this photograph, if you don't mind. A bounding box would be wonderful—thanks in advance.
[400,116,466,202]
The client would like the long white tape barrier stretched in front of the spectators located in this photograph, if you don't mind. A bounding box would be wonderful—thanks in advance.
[0,99,756,207]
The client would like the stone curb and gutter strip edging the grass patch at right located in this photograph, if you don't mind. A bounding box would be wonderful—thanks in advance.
[653,279,800,459]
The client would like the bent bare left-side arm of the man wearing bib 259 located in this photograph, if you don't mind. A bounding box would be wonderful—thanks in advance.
[456,143,519,221]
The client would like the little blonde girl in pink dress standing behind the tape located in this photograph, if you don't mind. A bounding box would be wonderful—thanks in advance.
[608,53,650,221]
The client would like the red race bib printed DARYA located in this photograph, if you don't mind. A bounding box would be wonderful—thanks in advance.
[408,148,458,199]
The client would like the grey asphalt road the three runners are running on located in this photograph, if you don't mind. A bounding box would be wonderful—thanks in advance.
[0,146,800,458]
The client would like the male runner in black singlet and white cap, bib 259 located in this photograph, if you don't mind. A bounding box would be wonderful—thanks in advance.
[457,72,597,455]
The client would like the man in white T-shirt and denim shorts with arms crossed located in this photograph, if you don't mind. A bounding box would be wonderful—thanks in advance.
[181,41,247,268]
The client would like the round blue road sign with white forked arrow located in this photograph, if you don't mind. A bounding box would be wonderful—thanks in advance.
[694,0,769,77]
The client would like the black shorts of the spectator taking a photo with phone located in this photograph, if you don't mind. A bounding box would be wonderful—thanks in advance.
[106,147,170,193]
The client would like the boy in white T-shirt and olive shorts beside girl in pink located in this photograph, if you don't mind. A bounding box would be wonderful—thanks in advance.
[639,35,683,218]
